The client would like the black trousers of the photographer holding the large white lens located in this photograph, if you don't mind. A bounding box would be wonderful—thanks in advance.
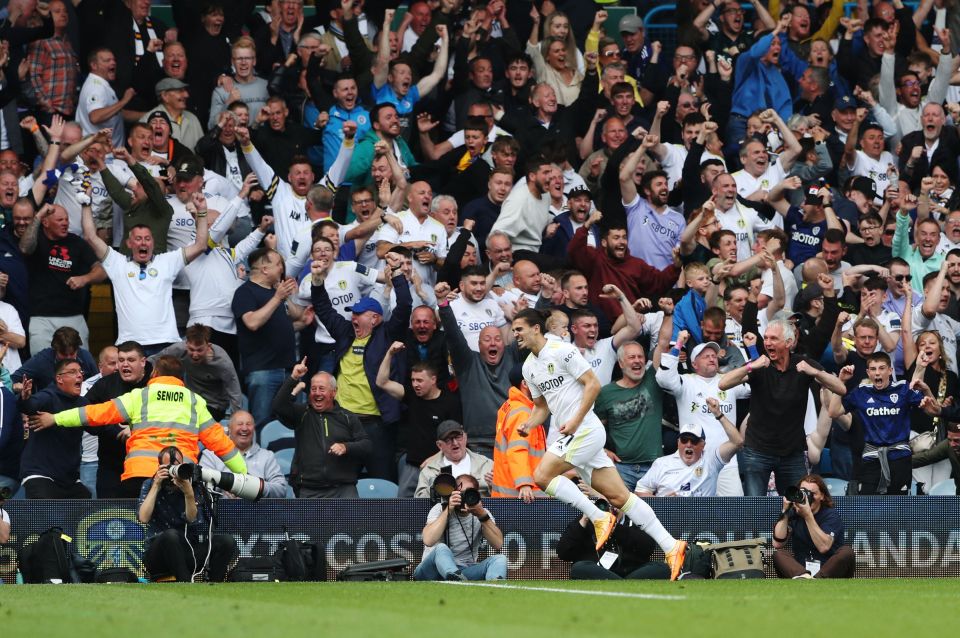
[143,529,240,583]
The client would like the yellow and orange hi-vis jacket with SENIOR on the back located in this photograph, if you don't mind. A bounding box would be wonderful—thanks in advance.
[54,377,247,480]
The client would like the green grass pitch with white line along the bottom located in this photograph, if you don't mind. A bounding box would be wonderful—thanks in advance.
[0,579,960,638]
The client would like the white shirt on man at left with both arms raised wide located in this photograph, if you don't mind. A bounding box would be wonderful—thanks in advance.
[103,248,187,345]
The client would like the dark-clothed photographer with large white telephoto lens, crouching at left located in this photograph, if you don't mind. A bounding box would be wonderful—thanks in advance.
[137,447,239,583]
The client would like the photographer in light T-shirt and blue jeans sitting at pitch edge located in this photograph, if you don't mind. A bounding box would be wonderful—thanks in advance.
[413,474,507,580]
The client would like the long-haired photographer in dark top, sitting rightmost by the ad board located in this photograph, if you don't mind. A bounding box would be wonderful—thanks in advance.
[773,474,856,578]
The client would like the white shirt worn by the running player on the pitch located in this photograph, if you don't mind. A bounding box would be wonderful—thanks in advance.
[523,339,603,432]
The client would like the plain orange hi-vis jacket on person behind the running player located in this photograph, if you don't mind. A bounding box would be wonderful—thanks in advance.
[490,387,547,498]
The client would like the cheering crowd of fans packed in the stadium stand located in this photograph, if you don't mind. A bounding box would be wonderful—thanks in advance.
[0,0,960,501]
